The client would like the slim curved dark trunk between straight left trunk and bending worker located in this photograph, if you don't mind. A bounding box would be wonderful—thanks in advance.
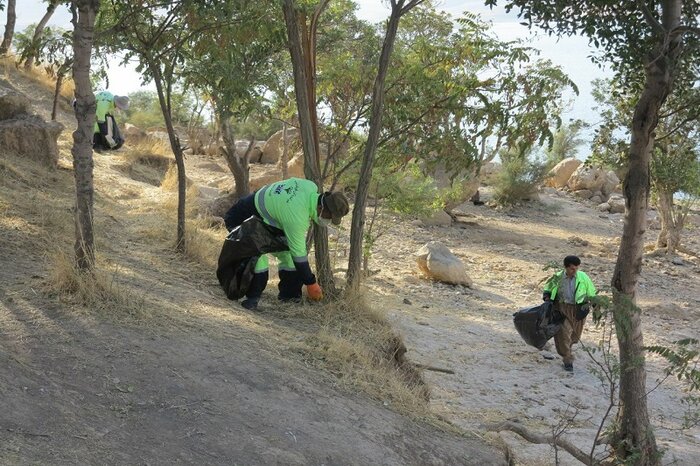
[148,63,187,251]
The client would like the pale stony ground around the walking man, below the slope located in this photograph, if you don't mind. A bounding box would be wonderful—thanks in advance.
[372,191,700,465]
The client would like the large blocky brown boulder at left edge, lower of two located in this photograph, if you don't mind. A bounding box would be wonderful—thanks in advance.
[0,116,63,168]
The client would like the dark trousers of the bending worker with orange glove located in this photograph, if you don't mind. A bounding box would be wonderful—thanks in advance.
[224,193,303,301]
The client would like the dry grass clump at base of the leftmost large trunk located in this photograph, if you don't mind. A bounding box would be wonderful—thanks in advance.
[46,251,146,318]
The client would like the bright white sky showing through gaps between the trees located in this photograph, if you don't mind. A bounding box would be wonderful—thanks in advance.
[13,0,610,138]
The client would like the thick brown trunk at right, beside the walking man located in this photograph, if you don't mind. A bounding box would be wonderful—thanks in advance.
[611,0,682,465]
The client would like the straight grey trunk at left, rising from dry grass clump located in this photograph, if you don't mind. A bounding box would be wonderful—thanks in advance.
[71,0,100,270]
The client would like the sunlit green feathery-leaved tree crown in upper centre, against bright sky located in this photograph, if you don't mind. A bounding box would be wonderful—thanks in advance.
[379,8,577,198]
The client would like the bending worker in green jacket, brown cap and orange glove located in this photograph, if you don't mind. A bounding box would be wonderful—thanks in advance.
[224,178,350,310]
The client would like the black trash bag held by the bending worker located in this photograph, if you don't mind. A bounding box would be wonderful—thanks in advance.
[216,216,289,299]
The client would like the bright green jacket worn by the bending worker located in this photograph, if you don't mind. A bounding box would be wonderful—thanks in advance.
[255,178,320,263]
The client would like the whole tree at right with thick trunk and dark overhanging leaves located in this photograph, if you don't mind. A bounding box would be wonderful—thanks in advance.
[486,0,700,465]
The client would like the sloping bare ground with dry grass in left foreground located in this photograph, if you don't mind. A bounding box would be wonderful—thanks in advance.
[0,70,505,465]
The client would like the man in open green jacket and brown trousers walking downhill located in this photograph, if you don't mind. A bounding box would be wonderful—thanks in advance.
[542,256,596,372]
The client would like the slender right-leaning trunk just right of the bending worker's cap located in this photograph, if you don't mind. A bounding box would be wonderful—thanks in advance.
[347,2,403,290]
